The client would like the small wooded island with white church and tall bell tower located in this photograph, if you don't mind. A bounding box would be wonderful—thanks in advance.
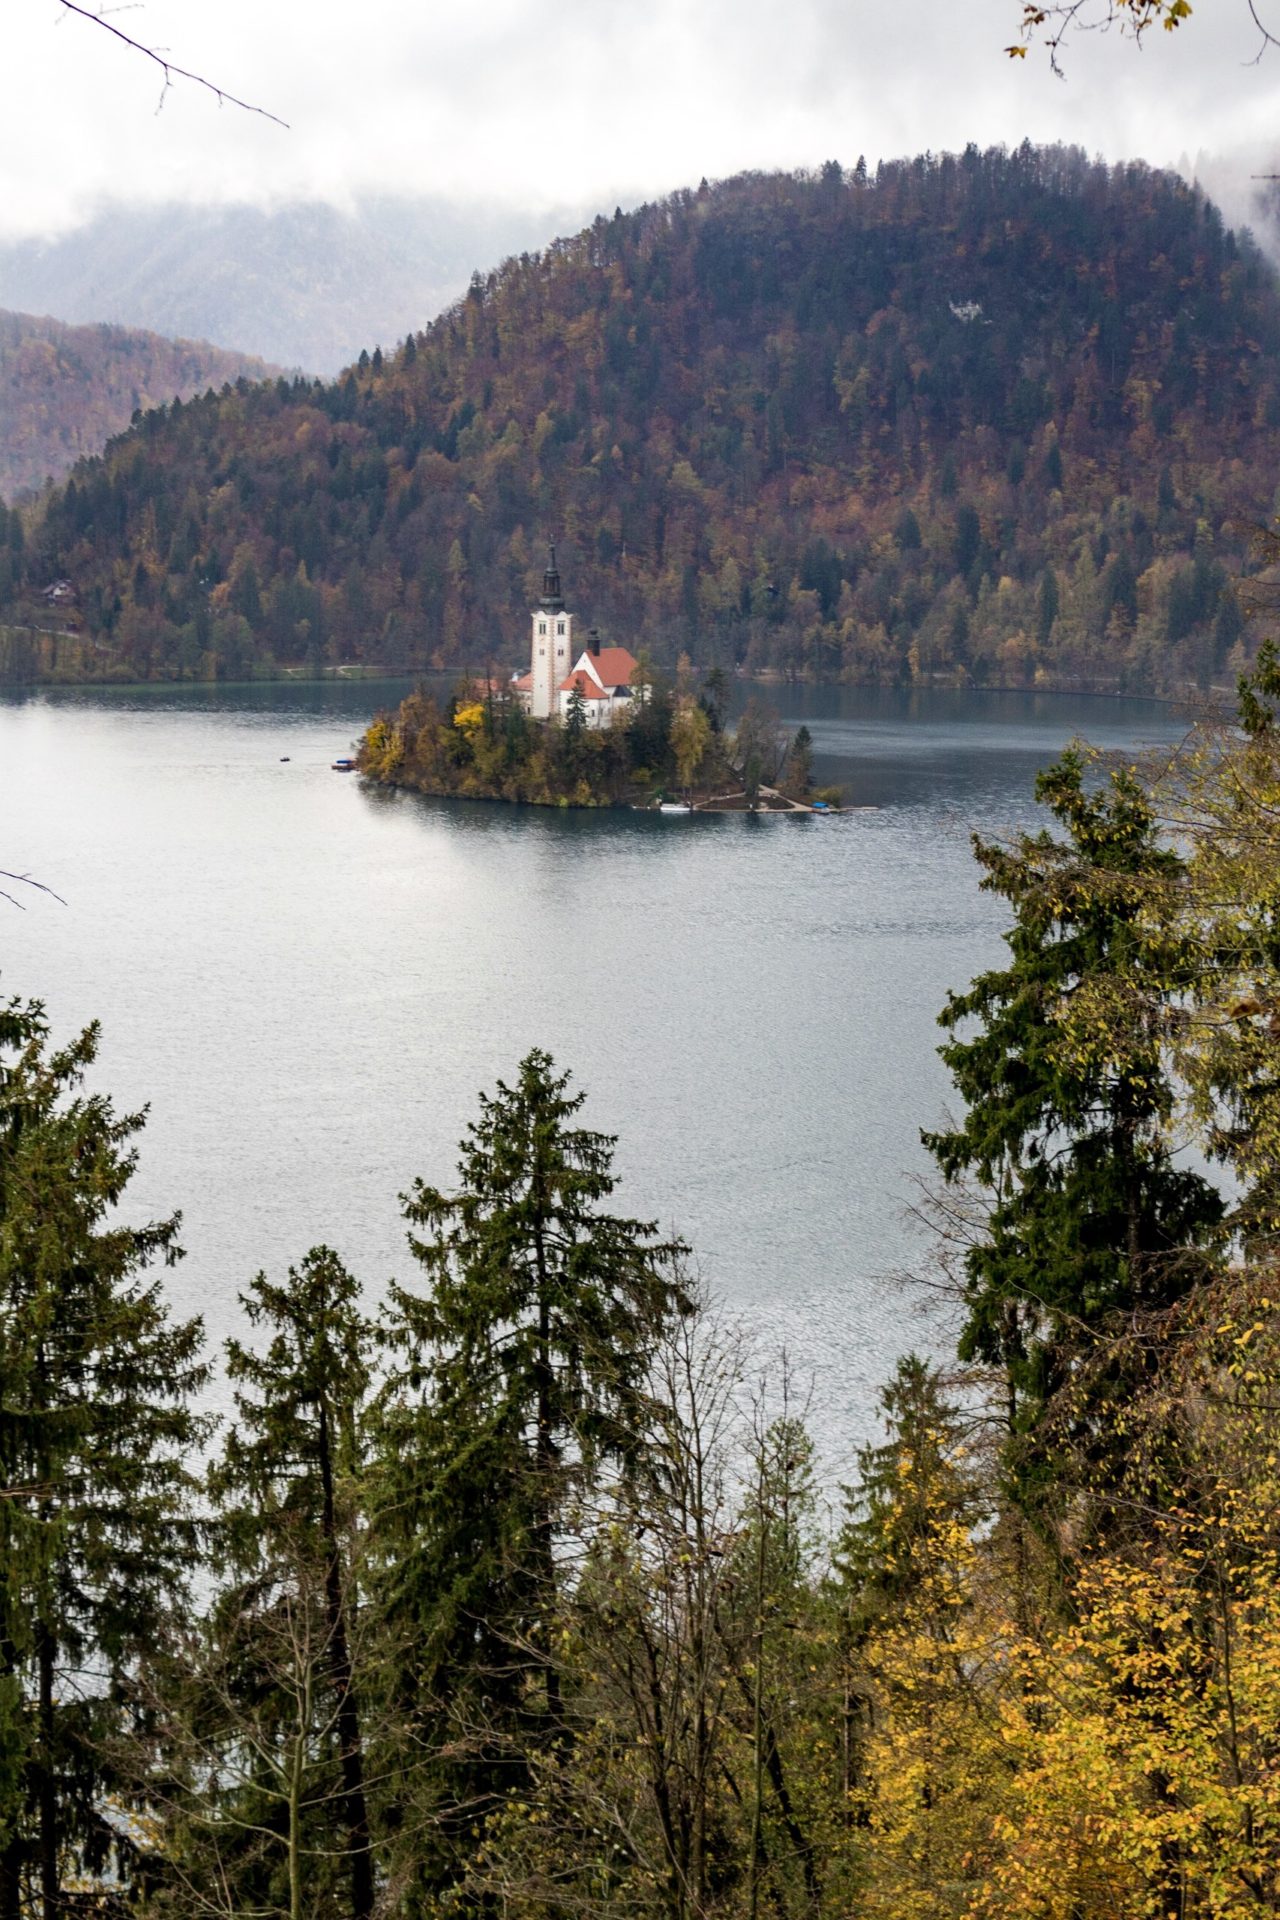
[357,547,841,812]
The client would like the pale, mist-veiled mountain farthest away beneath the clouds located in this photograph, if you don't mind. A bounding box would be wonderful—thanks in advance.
[0,196,583,374]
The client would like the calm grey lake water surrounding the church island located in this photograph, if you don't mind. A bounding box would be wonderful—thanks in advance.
[0,684,1182,1457]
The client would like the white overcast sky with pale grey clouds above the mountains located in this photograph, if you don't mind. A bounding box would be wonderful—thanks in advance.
[0,0,1280,236]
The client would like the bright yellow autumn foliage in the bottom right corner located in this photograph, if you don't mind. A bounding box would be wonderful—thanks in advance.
[971,1484,1280,1920]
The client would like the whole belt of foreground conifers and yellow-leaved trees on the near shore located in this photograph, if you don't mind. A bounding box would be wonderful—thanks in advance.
[12,643,1280,1920]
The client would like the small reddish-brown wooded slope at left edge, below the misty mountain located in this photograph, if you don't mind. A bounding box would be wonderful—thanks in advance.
[0,311,278,499]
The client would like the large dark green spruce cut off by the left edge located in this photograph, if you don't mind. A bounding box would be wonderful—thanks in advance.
[0,1000,203,1920]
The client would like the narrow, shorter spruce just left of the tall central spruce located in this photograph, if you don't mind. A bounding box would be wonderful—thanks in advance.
[157,1246,376,1920]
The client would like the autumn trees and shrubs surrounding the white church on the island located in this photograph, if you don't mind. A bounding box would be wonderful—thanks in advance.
[357,659,841,810]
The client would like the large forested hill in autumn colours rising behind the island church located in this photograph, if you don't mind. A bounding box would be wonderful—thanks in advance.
[10,146,1280,687]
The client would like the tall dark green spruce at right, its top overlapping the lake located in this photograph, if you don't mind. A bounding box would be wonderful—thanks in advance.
[923,749,1222,1501]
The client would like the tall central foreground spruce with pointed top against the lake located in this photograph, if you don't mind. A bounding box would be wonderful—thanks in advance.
[378,1050,683,1904]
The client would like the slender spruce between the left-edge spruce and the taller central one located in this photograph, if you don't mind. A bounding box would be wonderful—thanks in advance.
[182,1246,374,1920]
